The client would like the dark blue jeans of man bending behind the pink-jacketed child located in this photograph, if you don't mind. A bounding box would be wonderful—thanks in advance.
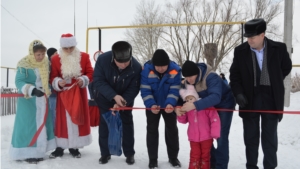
[210,111,233,169]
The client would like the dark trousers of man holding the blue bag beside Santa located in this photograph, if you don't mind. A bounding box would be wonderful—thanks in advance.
[99,110,135,157]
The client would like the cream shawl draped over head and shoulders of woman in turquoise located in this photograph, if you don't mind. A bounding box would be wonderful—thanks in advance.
[17,40,51,96]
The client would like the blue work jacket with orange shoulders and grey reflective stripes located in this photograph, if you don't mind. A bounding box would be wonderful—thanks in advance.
[141,61,181,108]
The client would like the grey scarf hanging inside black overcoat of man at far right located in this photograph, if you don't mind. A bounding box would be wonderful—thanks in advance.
[251,40,271,86]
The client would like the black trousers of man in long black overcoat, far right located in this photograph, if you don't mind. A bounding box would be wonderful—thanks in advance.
[243,112,278,169]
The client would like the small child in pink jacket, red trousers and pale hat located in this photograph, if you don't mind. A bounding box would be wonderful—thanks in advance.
[176,85,221,169]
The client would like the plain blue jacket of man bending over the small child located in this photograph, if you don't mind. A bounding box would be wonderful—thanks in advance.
[186,63,235,111]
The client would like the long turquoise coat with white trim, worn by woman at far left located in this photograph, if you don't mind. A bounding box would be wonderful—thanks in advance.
[9,67,56,160]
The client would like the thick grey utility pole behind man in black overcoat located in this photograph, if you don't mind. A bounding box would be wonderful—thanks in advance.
[283,0,294,107]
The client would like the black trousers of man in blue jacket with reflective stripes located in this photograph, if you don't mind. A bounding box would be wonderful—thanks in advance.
[146,110,179,159]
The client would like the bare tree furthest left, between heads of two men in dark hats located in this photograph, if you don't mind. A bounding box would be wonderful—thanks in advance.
[125,0,164,64]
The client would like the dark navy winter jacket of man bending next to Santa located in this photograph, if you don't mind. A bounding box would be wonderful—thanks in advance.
[91,51,142,113]
